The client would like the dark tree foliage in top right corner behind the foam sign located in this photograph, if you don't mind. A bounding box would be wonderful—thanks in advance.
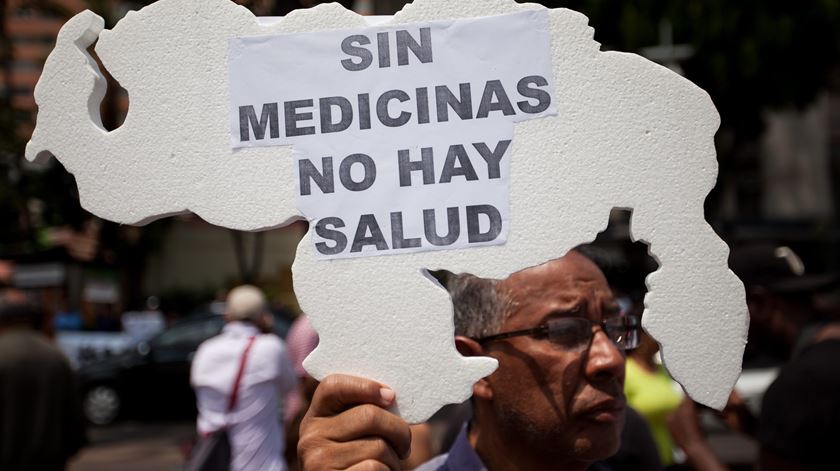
[556,0,840,136]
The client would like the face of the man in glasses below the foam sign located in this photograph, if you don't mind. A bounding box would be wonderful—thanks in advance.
[485,252,625,461]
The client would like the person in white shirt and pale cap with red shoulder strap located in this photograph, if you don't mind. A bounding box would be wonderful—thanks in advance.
[190,285,297,471]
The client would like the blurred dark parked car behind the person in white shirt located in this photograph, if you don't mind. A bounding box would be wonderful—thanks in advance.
[78,306,292,425]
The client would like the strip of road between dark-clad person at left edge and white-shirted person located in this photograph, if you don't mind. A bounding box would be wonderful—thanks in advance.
[69,422,195,471]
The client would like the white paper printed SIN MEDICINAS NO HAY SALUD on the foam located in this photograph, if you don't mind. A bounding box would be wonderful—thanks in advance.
[229,10,556,258]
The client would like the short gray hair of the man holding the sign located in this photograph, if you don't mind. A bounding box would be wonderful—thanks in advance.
[432,270,510,338]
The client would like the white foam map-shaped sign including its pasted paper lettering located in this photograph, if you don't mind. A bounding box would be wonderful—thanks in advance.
[26,0,747,422]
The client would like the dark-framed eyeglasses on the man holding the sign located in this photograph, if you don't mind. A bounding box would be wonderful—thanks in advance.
[473,316,639,351]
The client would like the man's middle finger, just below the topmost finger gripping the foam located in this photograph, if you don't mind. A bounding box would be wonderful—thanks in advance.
[324,404,411,458]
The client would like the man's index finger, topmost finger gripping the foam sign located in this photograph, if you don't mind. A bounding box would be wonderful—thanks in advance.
[307,375,395,417]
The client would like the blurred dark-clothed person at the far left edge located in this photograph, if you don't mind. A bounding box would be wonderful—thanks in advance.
[0,289,86,471]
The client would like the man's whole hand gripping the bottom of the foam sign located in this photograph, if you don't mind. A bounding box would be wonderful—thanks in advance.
[298,375,411,471]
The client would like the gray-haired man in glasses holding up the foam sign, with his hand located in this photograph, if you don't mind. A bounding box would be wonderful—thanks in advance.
[298,251,637,471]
